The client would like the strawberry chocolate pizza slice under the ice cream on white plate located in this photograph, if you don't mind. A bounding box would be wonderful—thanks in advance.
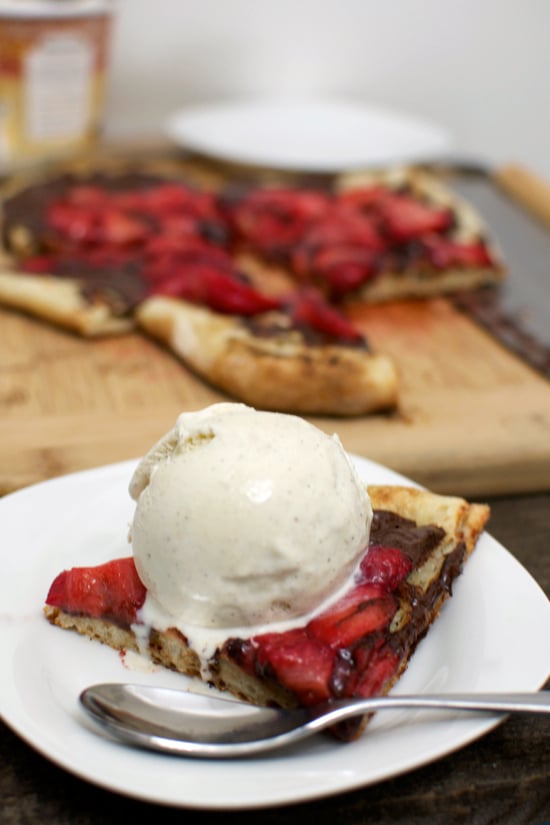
[45,485,489,739]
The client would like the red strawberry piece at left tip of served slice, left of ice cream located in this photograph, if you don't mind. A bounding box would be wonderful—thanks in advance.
[46,556,146,627]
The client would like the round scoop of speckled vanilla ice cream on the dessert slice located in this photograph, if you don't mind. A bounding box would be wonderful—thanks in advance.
[130,403,372,628]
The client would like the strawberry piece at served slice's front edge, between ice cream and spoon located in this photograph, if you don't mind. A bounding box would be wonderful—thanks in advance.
[255,628,334,705]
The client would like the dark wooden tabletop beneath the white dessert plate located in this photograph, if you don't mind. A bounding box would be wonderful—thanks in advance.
[0,494,550,825]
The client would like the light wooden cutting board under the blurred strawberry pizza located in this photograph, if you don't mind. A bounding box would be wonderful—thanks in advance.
[0,290,550,497]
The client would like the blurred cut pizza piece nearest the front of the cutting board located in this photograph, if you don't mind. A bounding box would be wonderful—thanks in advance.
[136,291,398,416]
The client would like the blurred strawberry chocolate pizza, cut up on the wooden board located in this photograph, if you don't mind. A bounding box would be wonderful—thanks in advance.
[0,156,503,415]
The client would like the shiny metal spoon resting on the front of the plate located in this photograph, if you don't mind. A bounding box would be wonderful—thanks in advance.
[80,683,550,758]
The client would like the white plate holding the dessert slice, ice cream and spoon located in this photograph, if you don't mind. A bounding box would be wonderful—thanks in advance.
[0,459,550,809]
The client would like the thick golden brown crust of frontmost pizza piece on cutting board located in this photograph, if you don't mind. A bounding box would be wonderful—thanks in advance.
[136,297,397,416]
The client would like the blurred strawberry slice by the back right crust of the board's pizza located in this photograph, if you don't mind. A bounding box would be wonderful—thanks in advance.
[379,194,453,243]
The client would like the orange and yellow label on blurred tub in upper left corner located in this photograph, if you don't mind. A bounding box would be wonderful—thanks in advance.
[0,8,110,166]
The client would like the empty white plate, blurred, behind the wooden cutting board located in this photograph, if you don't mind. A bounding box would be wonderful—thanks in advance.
[166,100,451,173]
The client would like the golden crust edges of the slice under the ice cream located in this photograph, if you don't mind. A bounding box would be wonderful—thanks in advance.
[45,485,489,733]
